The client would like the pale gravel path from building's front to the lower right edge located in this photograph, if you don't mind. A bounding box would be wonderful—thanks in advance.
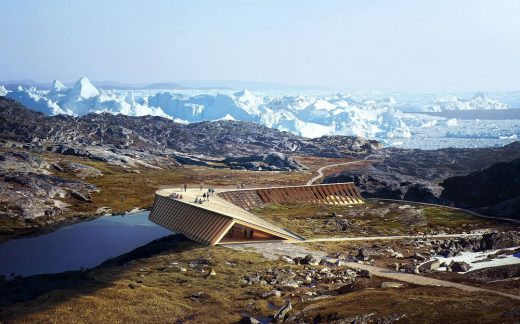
[225,242,520,300]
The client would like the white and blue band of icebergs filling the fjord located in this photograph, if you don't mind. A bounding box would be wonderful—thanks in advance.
[4,77,520,149]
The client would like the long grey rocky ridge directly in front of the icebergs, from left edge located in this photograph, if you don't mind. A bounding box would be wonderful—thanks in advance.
[0,97,382,157]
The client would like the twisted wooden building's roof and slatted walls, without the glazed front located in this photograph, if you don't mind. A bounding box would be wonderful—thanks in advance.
[149,183,363,245]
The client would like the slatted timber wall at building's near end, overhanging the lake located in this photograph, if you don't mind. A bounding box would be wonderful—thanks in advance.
[148,195,234,245]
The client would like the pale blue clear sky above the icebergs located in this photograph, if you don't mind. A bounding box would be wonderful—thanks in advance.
[0,0,520,91]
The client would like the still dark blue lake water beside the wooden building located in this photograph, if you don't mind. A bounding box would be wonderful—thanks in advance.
[0,211,172,279]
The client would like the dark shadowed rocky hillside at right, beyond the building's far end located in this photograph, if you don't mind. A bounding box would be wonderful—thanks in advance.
[323,142,520,209]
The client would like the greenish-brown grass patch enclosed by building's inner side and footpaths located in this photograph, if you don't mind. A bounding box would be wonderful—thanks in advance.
[251,201,510,239]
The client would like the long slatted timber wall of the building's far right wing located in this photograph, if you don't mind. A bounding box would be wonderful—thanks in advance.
[218,182,364,210]
